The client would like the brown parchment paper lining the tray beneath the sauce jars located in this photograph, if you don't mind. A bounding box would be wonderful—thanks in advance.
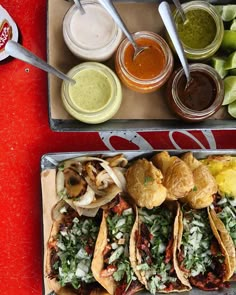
[48,0,229,120]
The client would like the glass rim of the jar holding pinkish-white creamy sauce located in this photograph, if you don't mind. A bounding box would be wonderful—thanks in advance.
[63,0,122,55]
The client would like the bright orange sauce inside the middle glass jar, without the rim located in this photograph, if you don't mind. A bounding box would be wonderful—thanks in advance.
[124,38,165,79]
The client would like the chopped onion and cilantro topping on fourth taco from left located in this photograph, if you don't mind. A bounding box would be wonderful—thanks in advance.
[181,209,213,276]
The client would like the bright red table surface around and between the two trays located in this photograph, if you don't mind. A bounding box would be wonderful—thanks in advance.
[0,0,236,295]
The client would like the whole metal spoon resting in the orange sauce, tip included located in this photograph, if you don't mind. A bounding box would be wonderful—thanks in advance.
[99,0,148,59]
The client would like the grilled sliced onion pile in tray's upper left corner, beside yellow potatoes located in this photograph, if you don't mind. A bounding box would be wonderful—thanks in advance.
[56,154,128,217]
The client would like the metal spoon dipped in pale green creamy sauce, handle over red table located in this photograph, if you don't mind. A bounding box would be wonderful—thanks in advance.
[5,40,76,84]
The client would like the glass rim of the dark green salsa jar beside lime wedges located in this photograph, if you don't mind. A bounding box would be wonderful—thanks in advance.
[174,1,224,59]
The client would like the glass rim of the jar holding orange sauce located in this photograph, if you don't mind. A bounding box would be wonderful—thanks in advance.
[116,31,173,85]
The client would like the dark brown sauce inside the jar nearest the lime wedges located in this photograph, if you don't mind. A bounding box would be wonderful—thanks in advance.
[177,71,217,111]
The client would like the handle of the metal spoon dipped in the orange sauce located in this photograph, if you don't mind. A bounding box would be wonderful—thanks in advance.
[99,0,137,49]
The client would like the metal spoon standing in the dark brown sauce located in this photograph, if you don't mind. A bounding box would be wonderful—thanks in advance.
[158,1,192,89]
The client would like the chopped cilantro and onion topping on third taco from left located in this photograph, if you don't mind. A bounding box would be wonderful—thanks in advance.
[138,207,177,294]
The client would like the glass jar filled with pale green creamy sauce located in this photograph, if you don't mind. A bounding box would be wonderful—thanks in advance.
[61,62,122,124]
